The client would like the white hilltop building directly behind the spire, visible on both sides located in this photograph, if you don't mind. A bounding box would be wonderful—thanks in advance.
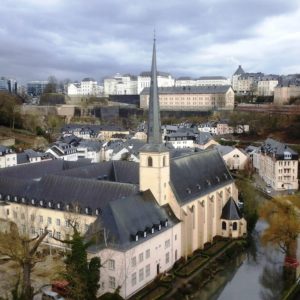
[137,72,175,94]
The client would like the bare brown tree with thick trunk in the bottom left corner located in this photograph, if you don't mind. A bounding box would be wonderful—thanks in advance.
[0,219,49,300]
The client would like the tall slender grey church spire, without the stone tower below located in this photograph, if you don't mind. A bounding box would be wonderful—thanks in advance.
[147,33,162,144]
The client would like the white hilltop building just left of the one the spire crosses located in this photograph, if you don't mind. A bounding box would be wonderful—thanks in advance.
[104,73,137,96]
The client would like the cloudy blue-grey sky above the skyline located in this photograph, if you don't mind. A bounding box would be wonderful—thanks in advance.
[0,0,300,83]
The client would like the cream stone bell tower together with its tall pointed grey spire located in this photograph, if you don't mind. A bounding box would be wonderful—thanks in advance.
[140,38,170,205]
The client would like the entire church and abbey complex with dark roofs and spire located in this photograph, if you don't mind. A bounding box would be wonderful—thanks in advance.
[0,40,247,299]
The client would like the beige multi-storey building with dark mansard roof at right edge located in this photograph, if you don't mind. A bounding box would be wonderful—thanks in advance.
[253,138,299,191]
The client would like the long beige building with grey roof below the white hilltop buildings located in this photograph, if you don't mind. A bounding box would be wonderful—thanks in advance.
[140,85,234,111]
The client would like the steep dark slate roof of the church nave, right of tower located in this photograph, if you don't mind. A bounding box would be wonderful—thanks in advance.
[170,149,233,205]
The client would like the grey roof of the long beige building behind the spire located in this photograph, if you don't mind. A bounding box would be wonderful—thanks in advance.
[141,85,231,95]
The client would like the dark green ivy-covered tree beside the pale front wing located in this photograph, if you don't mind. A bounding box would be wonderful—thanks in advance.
[55,220,101,300]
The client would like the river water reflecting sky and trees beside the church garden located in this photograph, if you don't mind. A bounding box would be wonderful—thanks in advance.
[190,221,284,300]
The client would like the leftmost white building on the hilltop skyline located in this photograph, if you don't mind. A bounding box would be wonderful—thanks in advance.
[68,78,103,96]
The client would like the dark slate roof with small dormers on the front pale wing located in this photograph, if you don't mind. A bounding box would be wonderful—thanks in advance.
[88,190,179,249]
